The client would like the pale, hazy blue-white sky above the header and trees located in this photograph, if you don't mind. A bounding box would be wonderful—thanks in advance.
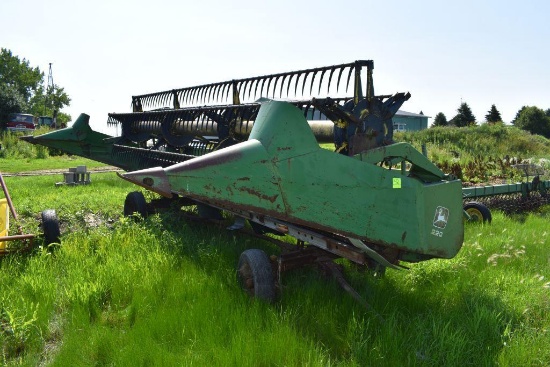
[0,0,550,134]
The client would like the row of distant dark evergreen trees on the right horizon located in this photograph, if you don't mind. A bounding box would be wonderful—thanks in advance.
[432,102,550,139]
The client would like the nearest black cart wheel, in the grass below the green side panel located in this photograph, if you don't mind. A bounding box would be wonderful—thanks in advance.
[237,249,275,303]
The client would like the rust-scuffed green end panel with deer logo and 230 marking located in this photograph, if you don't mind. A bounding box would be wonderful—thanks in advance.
[124,101,463,261]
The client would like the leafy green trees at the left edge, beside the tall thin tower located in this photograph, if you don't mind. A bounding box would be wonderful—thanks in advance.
[0,48,71,125]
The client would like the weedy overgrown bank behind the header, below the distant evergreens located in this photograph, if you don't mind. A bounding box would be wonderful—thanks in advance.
[395,124,550,183]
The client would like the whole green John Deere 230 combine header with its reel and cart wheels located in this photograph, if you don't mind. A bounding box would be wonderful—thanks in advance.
[20,61,463,308]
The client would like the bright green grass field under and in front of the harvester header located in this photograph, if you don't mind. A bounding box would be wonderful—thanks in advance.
[0,152,550,366]
